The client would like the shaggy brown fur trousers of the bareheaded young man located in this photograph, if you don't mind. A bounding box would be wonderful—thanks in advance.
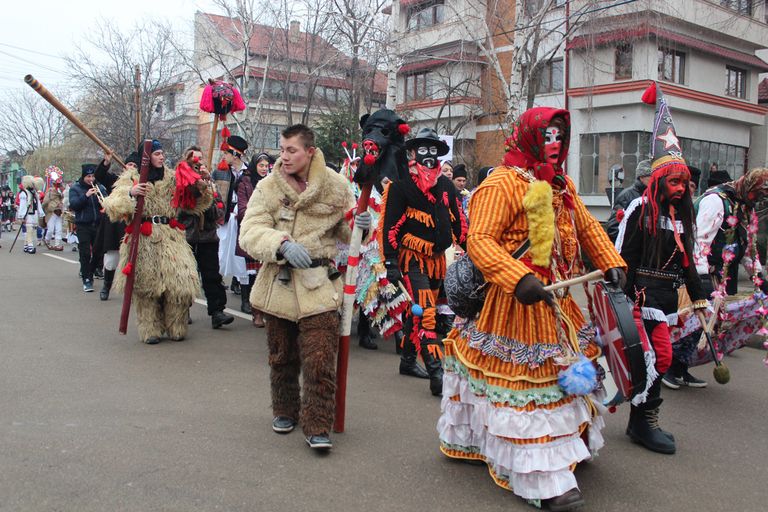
[266,311,339,436]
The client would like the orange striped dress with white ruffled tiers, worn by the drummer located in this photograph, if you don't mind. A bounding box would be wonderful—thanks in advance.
[438,167,625,501]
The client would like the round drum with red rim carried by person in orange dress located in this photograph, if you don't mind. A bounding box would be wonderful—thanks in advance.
[592,281,651,401]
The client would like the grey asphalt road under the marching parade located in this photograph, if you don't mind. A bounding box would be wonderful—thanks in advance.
[0,246,768,512]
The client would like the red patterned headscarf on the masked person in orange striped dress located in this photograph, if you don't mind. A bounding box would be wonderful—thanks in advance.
[504,107,573,209]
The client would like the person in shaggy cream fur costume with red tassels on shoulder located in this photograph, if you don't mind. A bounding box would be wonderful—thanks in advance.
[103,140,213,345]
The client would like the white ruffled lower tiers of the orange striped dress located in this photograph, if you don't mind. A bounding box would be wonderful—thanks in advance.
[437,372,604,500]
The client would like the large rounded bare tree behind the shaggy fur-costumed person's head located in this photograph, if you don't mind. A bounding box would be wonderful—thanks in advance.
[67,20,181,158]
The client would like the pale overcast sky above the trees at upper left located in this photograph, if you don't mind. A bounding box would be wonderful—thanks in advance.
[0,0,218,97]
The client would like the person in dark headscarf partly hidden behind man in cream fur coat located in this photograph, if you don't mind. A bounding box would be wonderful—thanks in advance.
[235,153,274,327]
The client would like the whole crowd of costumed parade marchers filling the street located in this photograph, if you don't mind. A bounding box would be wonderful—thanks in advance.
[10,87,768,511]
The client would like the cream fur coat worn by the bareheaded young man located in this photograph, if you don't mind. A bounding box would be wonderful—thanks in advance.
[239,149,354,322]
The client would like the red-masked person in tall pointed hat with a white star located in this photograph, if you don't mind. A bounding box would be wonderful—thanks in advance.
[616,83,707,454]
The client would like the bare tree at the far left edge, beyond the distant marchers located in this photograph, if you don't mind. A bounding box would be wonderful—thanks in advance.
[0,89,70,155]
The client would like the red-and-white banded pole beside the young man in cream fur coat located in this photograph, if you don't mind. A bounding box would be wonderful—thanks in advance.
[333,184,372,432]
